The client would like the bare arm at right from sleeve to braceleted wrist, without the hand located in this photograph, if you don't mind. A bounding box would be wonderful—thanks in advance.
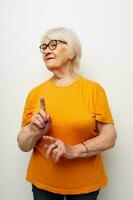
[72,122,116,157]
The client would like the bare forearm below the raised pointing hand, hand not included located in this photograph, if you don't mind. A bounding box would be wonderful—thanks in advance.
[17,125,41,152]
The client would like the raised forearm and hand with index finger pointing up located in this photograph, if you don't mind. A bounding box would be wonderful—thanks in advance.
[17,97,51,152]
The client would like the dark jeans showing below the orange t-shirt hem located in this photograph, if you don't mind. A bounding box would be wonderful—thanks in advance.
[32,185,99,200]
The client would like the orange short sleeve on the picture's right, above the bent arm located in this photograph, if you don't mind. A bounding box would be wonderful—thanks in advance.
[94,84,114,124]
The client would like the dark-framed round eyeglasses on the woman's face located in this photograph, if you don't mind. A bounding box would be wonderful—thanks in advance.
[39,40,67,54]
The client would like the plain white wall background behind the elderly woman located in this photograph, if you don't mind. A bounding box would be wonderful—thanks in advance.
[0,0,133,200]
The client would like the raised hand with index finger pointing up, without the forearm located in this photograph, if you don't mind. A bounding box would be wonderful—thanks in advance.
[30,97,51,136]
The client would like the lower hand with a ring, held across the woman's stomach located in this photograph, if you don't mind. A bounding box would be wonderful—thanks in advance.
[43,136,84,162]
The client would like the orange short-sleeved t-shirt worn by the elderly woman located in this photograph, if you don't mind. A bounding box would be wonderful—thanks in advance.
[22,76,114,194]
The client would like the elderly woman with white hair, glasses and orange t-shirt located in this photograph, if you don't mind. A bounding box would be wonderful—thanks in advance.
[17,27,116,200]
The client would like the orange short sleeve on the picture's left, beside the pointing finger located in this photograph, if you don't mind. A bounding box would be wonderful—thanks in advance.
[21,92,33,127]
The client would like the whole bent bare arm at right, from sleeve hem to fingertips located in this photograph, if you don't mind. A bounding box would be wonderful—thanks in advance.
[43,122,116,162]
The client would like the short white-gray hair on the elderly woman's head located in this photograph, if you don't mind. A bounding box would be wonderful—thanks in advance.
[41,27,82,68]
